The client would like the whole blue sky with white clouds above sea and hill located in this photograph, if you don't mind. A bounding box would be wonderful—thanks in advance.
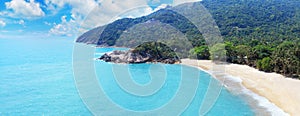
[0,0,202,39]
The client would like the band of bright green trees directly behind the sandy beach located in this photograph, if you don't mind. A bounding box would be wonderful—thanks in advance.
[192,41,300,78]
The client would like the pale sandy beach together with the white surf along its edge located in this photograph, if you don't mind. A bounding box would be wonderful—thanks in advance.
[181,59,300,115]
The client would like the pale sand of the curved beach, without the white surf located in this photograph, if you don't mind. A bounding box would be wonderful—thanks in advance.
[182,59,300,116]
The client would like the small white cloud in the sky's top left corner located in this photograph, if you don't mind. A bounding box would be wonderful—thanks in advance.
[0,0,45,19]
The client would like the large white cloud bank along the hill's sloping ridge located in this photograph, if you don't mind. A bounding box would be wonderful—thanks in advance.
[45,0,195,35]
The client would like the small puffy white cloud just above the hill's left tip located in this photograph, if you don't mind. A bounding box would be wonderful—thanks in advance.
[49,16,78,36]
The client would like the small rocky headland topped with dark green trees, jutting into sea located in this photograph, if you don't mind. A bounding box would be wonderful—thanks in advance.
[98,42,181,64]
